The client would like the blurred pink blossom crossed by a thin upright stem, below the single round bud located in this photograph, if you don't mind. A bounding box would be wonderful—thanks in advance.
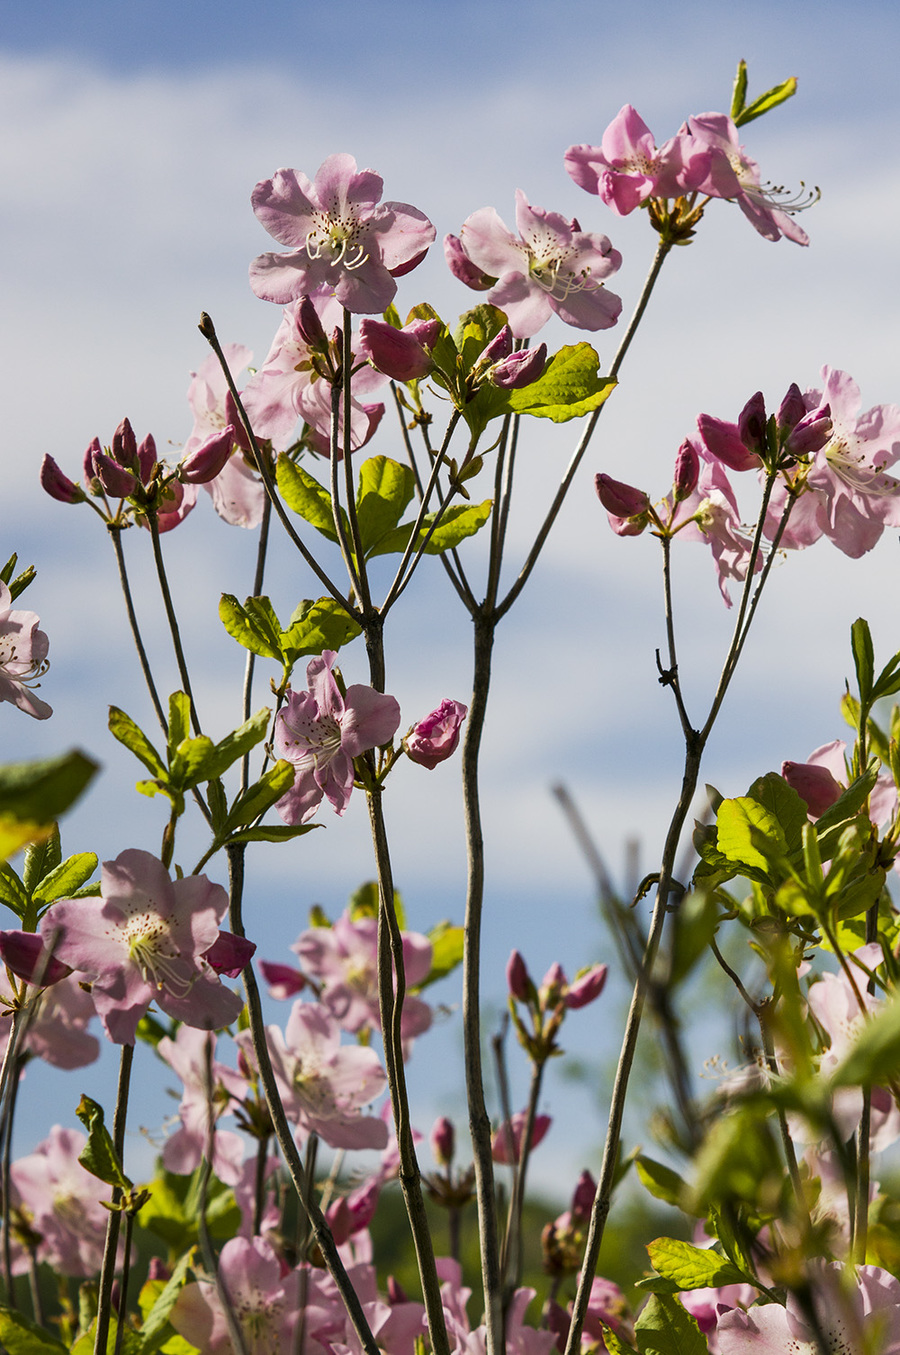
[291,913,432,1042]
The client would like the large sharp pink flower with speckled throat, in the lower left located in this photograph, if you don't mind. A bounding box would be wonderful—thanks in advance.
[41,848,243,1045]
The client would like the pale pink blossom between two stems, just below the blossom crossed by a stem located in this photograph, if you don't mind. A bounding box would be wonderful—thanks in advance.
[237,1001,388,1148]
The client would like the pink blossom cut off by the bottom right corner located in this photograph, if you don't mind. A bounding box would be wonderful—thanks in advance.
[717,1264,900,1355]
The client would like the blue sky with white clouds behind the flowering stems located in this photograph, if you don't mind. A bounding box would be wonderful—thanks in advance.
[0,0,900,1203]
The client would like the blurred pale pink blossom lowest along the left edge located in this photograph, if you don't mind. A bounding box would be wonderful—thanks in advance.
[9,1125,110,1279]
